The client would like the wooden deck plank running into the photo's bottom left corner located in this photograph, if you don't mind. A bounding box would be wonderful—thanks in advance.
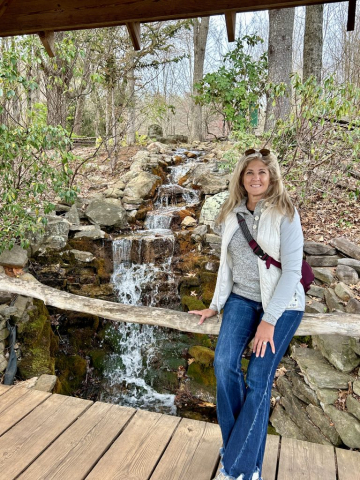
[0,394,93,479]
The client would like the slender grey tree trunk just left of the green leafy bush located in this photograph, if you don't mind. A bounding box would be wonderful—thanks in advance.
[190,17,210,141]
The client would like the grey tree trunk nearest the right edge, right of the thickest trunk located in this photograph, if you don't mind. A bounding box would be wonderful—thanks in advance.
[303,5,324,83]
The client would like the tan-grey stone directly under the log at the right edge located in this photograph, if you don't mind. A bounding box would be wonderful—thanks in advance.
[312,335,360,372]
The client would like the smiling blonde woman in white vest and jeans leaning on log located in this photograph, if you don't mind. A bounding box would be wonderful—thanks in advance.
[189,149,305,480]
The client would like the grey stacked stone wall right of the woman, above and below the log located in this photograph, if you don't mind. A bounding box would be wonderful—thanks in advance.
[270,237,360,448]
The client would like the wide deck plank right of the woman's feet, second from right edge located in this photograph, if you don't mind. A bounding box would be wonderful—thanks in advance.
[278,437,336,480]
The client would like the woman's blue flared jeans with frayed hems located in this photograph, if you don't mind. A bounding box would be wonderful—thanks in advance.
[214,293,304,480]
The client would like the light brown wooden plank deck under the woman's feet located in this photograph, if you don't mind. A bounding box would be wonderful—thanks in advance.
[0,385,360,480]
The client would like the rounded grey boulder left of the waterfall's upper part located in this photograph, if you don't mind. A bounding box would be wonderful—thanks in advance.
[85,198,127,228]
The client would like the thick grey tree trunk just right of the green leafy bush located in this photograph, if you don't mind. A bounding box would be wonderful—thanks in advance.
[265,8,295,130]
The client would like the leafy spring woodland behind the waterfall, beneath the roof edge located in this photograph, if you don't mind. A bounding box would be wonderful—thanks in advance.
[0,3,360,250]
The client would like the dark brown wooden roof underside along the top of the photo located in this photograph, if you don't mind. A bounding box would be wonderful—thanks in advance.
[0,0,348,36]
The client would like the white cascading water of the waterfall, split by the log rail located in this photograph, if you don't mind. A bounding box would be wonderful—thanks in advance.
[103,152,207,414]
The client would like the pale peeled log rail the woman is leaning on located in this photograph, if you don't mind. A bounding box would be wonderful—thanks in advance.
[0,274,360,337]
